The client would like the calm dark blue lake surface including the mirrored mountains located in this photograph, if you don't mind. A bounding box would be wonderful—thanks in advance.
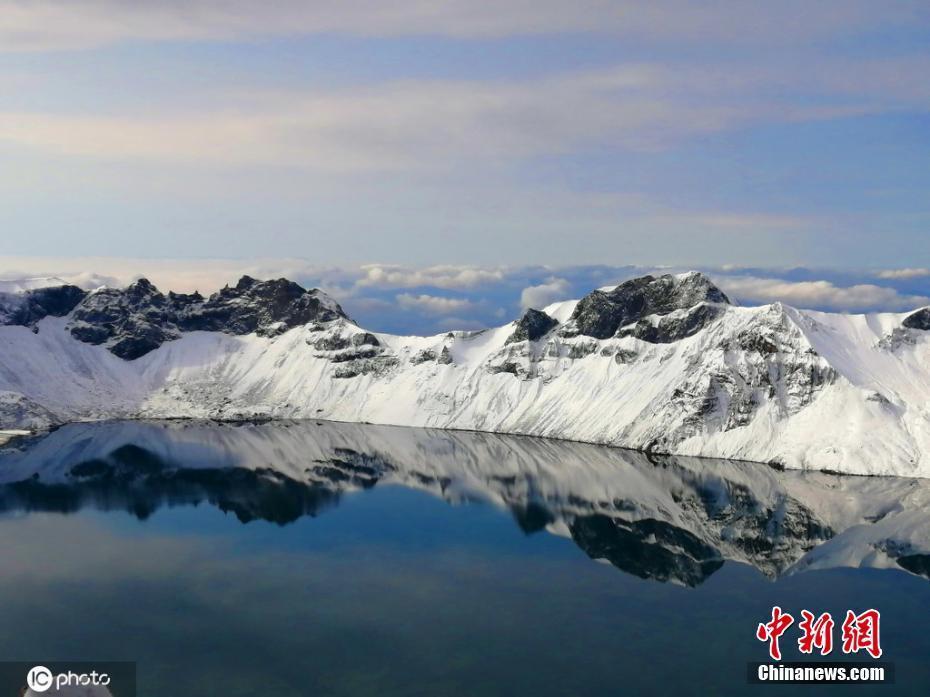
[0,423,930,697]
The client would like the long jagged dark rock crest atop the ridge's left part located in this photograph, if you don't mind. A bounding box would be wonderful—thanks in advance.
[69,276,346,360]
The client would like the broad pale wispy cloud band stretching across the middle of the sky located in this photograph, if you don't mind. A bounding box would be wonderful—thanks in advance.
[0,58,930,172]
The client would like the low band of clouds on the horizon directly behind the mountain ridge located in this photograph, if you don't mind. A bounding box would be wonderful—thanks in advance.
[0,257,930,334]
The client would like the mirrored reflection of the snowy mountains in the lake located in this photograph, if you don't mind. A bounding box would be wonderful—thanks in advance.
[0,422,930,586]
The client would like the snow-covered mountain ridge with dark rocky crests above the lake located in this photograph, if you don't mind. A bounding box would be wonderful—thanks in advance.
[0,272,930,477]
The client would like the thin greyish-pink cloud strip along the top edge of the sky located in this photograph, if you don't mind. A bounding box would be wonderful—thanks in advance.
[0,0,926,51]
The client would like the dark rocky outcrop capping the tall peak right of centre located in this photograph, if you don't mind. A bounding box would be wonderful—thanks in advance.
[572,273,730,339]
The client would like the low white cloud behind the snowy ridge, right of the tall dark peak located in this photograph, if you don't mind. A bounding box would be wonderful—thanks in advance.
[715,276,930,312]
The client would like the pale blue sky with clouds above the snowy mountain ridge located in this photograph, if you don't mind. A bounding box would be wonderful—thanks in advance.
[0,0,930,331]
